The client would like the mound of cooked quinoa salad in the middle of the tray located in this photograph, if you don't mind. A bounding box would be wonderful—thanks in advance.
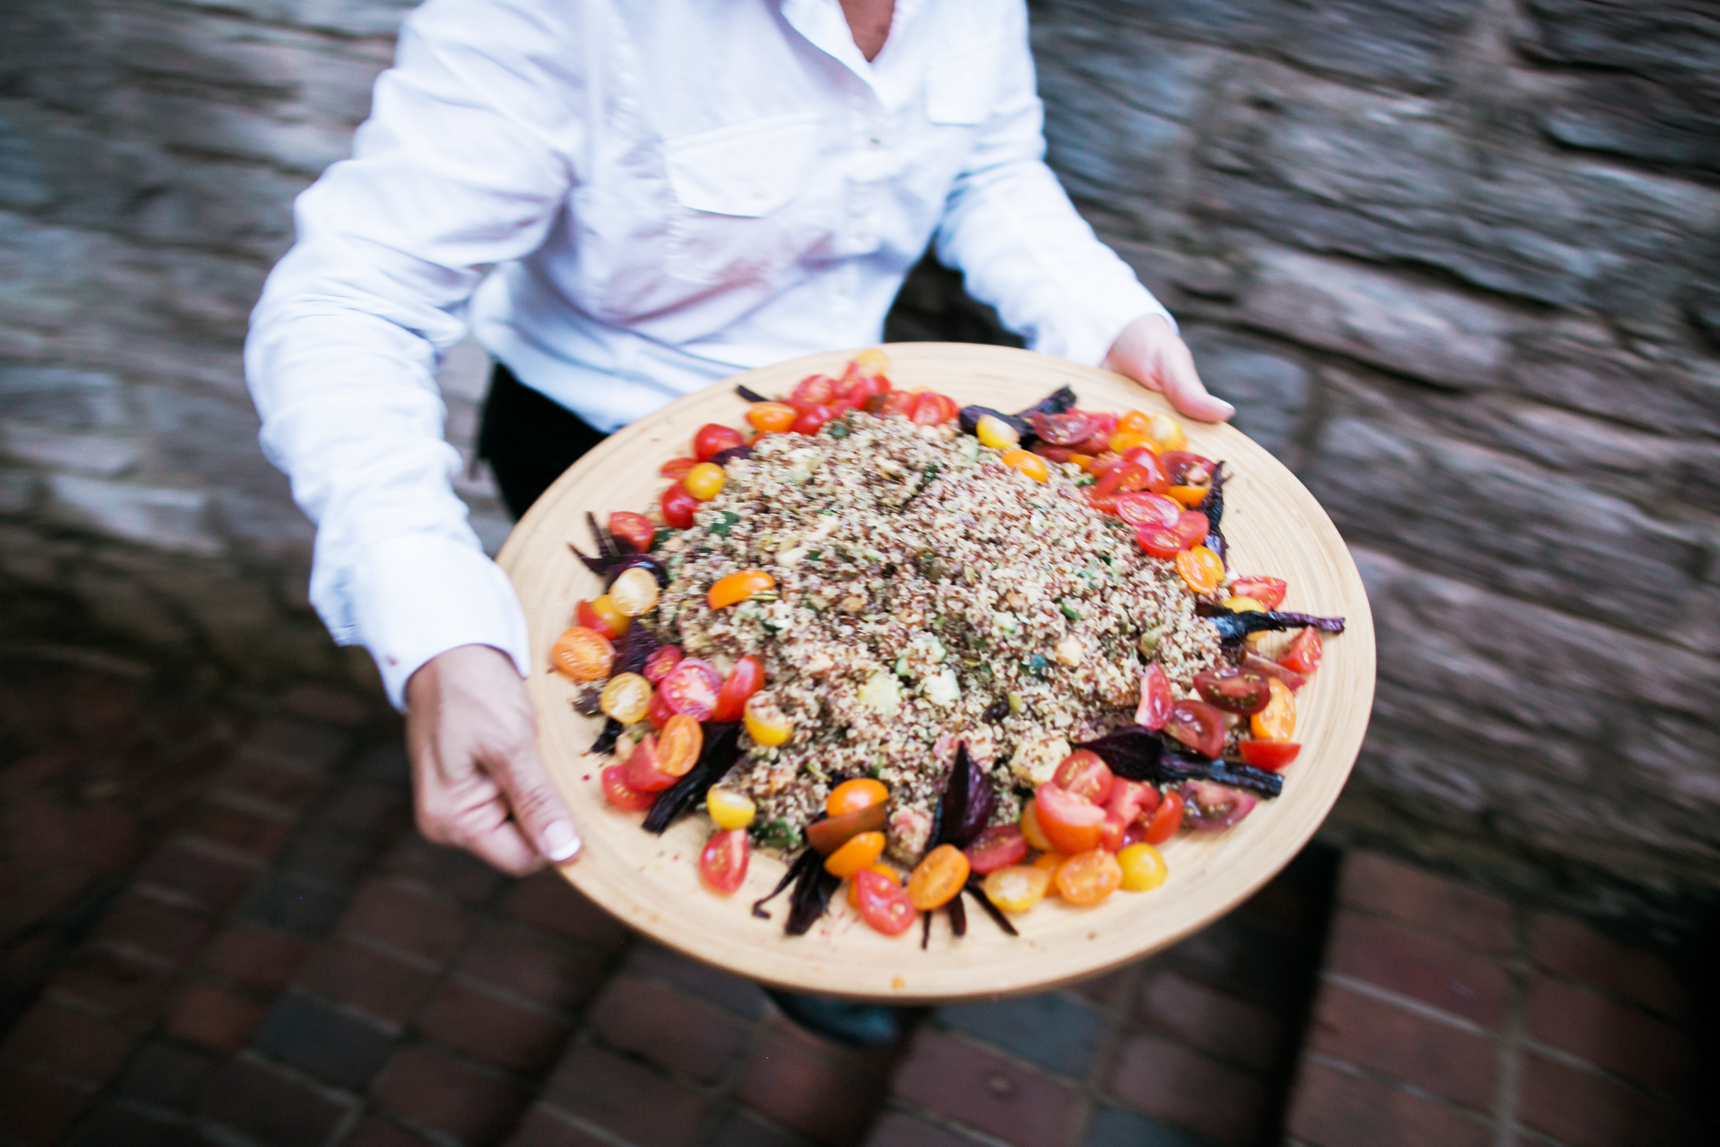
[657,413,1218,862]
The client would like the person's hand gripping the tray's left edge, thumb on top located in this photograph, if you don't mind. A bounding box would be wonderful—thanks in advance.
[406,645,580,875]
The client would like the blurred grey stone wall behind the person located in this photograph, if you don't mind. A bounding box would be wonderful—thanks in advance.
[0,0,1720,908]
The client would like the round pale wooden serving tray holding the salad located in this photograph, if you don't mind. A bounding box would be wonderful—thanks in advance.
[499,342,1374,1004]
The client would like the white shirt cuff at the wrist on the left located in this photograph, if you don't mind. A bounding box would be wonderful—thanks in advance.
[349,533,531,708]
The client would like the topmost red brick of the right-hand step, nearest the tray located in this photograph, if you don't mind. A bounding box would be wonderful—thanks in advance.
[1338,850,1517,956]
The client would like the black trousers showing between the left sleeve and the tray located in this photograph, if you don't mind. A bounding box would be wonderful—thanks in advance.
[478,363,609,521]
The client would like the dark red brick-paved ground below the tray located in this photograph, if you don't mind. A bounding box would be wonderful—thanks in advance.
[0,662,1699,1147]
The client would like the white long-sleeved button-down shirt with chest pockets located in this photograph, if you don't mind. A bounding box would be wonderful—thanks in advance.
[246,0,1170,703]
